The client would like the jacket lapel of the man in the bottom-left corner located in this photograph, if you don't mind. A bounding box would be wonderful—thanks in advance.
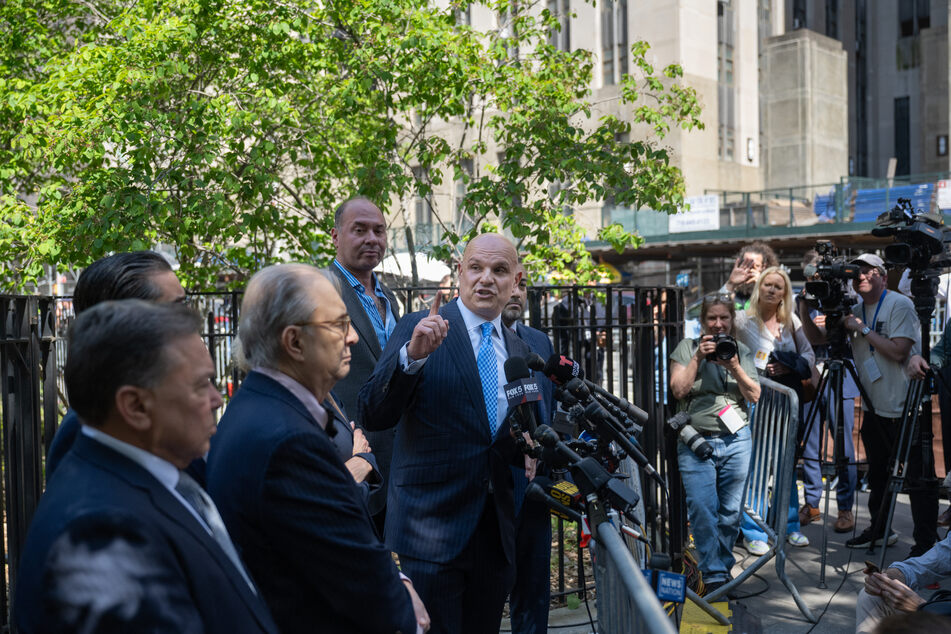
[74,434,269,629]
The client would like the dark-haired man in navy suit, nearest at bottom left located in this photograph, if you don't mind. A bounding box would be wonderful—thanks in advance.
[13,300,277,634]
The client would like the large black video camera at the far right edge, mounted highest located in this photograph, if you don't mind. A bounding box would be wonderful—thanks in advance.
[872,198,951,271]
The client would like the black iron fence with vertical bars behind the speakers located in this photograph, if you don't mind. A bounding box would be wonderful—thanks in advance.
[0,286,685,626]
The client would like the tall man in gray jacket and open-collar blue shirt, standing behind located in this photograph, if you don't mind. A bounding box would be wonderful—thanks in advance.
[330,197,400,537]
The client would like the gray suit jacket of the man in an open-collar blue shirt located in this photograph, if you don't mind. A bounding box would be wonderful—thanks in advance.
[329,264,400,515]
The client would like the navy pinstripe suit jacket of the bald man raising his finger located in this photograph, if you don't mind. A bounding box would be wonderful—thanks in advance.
[360,300,530,563]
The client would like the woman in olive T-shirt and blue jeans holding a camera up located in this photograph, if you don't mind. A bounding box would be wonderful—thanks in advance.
[670,295,760,593]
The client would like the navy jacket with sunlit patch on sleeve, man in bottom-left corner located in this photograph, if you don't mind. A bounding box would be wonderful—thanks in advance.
[13,434,277,634]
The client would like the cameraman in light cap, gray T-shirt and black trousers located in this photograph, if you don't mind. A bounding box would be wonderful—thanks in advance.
[843,253,938,557]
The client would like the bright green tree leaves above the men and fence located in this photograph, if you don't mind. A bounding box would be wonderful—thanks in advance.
[0,0,700,288]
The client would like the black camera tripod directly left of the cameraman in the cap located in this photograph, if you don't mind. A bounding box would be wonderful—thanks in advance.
[797,334,871,589]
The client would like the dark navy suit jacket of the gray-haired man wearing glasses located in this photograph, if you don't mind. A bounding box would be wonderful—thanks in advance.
[207,372,416,634]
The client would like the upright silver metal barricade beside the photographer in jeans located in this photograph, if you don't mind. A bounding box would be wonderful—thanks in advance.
[704,377,816,623]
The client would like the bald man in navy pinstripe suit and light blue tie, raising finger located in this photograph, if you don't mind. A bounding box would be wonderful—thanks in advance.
[360,234,534,634]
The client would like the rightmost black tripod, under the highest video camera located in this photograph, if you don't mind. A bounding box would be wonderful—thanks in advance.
[866,268,938,570]
